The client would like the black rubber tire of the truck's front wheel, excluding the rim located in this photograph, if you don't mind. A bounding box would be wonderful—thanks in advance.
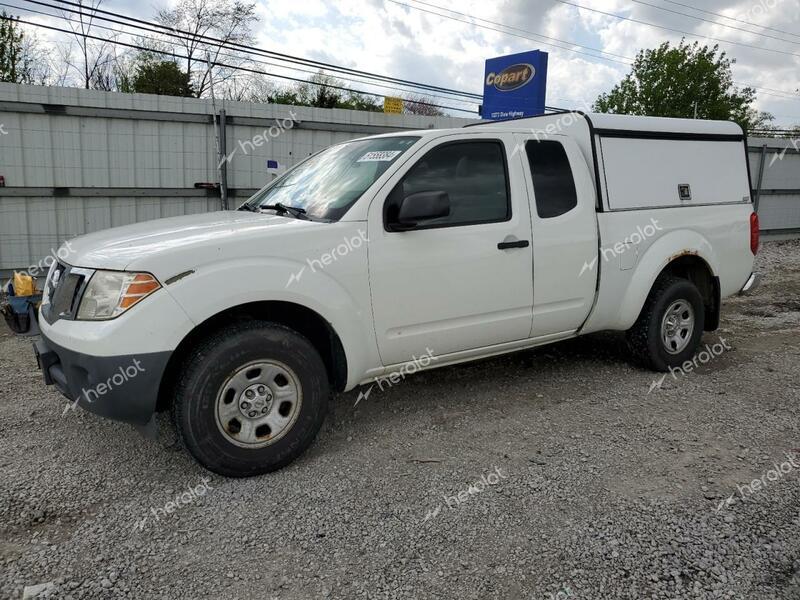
[173,321,330,477]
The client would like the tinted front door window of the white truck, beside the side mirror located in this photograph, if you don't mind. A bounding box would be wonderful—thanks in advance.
[384,140,511,229]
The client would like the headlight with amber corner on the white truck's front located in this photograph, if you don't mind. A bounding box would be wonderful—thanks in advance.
[78,271,161,321]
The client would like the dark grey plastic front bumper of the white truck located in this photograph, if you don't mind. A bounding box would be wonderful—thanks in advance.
[33,334,172,427]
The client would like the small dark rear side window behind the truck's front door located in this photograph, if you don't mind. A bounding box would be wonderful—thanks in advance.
[525,140,578,219]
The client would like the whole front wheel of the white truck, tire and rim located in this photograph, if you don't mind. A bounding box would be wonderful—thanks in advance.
[173,321,330,477]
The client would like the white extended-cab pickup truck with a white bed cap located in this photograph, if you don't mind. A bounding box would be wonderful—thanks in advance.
[35,112,758,476]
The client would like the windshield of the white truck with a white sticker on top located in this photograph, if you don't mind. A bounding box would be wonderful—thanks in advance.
[246,136,419,221]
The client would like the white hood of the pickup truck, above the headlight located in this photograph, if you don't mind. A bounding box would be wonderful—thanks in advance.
[65,211,325,270]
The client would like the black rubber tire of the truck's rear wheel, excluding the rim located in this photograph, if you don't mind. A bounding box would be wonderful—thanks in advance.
[627,275,705,371]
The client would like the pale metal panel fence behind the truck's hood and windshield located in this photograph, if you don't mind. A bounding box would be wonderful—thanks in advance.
[0,83,470,271]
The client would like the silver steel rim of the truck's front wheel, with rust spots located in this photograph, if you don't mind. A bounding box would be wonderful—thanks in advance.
[216,360,303,449]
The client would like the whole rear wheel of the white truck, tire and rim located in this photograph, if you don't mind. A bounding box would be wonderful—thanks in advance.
[627,275,705,371]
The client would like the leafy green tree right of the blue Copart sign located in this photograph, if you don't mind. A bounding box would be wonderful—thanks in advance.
[594,40,773,130]
